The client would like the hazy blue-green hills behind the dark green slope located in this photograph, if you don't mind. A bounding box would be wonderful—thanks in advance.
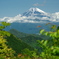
[9,29,42,48]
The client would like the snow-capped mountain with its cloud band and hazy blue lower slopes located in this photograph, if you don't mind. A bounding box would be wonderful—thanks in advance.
[0,8,59,34]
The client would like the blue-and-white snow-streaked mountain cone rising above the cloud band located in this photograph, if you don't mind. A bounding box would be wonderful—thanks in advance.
[22,8,47,17]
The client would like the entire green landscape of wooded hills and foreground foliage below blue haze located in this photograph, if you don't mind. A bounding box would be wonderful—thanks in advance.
[0,22,59,59]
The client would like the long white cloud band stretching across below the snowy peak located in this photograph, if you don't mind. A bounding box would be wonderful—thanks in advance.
[0,13,59,23]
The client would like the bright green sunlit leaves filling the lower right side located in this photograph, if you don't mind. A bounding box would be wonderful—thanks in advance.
[38,25,59,59]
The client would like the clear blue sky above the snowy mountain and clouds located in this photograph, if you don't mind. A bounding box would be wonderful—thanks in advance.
[0,0,59,18]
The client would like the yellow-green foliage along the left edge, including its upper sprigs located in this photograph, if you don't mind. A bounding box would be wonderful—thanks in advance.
[0,22,14,59]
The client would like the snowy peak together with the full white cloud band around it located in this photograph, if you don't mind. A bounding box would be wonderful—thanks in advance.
[0,8,59,23]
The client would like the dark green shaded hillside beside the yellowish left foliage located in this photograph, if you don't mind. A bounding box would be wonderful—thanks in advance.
[6,34,33,53]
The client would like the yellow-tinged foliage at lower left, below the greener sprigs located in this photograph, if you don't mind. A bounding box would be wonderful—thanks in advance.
[0,28,15,59]
